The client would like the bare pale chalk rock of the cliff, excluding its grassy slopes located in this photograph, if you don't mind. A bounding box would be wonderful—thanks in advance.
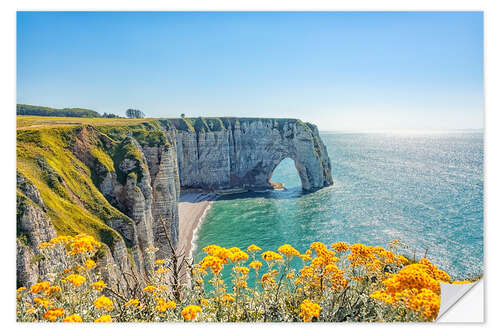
[17,118,333,288]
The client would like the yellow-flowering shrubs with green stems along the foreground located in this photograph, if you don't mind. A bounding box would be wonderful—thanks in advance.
[17,235,468,322]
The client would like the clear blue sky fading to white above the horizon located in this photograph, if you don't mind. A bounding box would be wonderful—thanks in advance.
[17,12,484,130]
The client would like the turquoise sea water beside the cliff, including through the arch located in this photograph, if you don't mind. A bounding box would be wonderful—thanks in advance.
[195,131,483,279]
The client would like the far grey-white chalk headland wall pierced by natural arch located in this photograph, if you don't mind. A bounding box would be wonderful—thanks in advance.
[177,118,333,191]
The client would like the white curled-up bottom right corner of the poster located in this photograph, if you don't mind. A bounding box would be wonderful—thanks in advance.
[436,279,484,323]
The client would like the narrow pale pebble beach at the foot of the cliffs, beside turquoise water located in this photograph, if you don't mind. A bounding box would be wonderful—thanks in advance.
[177,191,217,258]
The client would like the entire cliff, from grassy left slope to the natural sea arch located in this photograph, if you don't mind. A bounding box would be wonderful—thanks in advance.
[17,118,333,290]
